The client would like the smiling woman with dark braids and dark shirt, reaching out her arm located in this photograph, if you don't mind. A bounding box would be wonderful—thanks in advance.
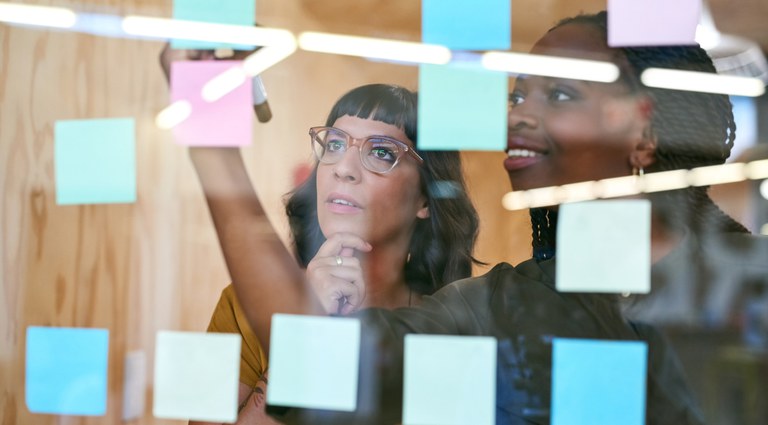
[189,9,764,424]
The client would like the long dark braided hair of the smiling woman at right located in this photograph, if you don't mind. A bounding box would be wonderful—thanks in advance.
[531,11,748,259]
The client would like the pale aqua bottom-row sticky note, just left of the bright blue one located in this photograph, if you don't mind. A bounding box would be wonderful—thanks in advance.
[403,334,496,425]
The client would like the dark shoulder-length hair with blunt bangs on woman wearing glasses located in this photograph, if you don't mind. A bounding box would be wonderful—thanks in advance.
[285,84,479,294]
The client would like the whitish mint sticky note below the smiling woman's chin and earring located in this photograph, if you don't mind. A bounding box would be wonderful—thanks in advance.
[555,199,651,294]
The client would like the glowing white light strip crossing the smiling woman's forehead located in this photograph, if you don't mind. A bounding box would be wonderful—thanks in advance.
[481,52,619,83]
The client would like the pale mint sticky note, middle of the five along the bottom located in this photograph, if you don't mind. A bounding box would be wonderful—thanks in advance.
[267,314,360,412]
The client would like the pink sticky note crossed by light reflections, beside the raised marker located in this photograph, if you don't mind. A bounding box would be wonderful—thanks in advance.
[171,61,253,146]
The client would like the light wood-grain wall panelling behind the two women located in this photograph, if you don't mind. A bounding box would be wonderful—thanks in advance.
[0,0,765,425]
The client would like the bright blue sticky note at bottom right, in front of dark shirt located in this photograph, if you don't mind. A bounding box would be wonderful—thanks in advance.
[551,338,648,425]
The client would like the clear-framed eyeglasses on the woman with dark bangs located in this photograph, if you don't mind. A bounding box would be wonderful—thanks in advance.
[309,127,424,174]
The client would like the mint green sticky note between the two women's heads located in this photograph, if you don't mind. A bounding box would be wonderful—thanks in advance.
[418,65,508,151]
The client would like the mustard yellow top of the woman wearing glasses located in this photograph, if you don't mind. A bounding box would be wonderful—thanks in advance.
[208,284,267,388]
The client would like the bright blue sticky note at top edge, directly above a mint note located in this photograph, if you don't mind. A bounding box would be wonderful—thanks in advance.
[421,0,512,50]
